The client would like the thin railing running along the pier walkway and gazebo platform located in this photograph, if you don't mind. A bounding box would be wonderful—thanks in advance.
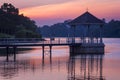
[0,37,100,44]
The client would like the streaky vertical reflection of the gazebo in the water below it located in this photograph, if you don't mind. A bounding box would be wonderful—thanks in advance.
[68,55,105,80]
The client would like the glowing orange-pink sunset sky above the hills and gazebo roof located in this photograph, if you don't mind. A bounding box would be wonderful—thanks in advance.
[20,0,120,25]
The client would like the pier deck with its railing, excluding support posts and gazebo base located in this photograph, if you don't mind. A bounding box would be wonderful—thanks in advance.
[0,38,101,47]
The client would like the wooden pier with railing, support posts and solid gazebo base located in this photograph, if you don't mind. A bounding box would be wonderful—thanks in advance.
[0,38,104,61]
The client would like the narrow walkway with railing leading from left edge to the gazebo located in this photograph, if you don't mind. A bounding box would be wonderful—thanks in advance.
[0,40,81,47]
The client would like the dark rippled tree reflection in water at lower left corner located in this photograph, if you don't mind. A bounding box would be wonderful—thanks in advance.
[0,61,30,79]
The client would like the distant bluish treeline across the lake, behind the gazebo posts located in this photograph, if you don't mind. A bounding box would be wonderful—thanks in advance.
[39,20,120,38]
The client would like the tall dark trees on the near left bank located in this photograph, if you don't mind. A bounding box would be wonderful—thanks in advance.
[0,3,41,38]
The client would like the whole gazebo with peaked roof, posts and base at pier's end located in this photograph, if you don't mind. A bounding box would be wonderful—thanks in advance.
[68,11,104,53]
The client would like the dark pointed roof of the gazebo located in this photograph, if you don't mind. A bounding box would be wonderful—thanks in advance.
[68,11,104,25]
